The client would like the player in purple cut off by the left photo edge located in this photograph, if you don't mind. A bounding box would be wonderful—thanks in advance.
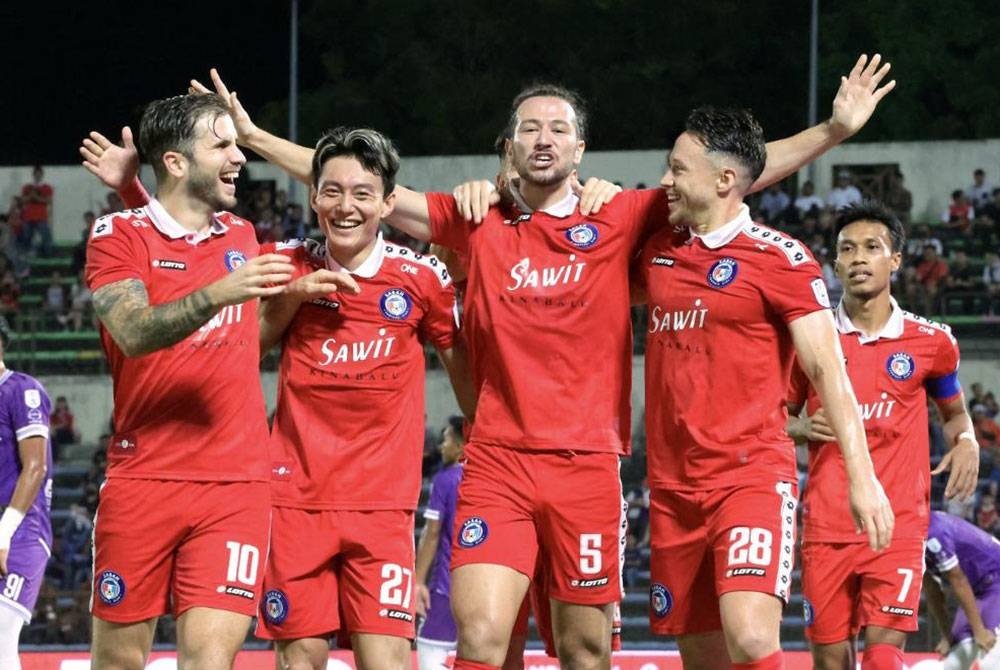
[0,317,52,670]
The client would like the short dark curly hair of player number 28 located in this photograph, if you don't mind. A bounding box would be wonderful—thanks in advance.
[684,106,767,184]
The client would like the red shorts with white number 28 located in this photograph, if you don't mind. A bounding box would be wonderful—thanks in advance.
[649,482,798,635]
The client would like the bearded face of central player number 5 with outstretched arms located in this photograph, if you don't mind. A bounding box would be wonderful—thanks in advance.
[511,96,584,186]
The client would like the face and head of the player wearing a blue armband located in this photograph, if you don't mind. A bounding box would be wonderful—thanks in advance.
[834,220,902,300]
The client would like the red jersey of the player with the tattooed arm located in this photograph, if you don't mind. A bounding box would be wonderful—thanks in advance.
[87,200,268,481]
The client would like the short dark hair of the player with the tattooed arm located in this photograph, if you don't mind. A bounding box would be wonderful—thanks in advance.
[139,93,229,180]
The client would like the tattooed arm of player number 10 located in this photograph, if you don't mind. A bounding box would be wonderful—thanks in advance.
[94,279,219,356]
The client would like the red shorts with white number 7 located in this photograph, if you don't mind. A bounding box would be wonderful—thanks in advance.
[802,539,924,644]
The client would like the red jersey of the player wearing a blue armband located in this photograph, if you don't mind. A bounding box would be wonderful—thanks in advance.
[790,300,962,542]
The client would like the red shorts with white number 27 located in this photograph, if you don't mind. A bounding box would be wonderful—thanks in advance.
[256,507,415,646]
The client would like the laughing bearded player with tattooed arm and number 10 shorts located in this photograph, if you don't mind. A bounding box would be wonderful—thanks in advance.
[87,96,354,667]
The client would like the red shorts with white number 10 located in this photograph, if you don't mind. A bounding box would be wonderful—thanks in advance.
[90,477,271,623]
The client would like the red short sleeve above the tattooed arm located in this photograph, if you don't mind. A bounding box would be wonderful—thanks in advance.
[86,214,148,292]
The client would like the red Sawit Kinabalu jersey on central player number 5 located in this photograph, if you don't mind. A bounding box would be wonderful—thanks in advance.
[427,189,667,454]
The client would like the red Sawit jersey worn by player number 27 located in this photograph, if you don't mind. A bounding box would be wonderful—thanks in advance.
[271,236,457,510]
